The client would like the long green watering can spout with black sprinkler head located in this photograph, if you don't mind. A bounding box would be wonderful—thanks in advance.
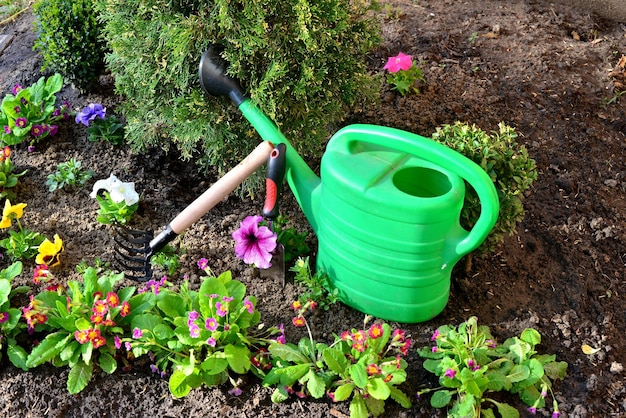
[198,45,321,231]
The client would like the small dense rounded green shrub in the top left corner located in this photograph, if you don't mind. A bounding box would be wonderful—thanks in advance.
[33,0,106,91]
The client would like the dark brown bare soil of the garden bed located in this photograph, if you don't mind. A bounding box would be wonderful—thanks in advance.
[0,0,626,418]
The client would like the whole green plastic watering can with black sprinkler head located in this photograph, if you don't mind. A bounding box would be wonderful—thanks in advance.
[199,49,499,323]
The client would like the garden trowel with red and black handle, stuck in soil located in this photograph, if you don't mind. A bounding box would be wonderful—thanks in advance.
[261,144,287,287]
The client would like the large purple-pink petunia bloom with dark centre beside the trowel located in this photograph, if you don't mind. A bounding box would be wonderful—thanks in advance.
[232,215,277,269]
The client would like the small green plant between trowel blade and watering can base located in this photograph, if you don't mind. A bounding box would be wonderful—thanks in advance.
[289,257,339,311]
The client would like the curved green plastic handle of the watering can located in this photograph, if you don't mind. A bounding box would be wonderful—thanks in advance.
[335,124,500,258]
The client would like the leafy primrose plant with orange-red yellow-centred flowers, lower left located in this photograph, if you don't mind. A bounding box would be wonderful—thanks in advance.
[23,267,135,394]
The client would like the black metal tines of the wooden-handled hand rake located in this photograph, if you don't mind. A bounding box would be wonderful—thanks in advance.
[113,225,154,281]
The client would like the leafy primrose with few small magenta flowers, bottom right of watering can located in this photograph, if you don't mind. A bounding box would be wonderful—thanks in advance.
[418,317,567,418]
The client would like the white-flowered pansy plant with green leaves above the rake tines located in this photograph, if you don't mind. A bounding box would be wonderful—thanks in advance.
[89,174,139,225]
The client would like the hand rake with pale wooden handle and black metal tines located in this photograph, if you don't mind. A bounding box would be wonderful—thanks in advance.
[114,141,274,281]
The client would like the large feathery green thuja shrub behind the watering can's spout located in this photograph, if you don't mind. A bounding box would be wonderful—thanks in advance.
[100,0,381,189]
